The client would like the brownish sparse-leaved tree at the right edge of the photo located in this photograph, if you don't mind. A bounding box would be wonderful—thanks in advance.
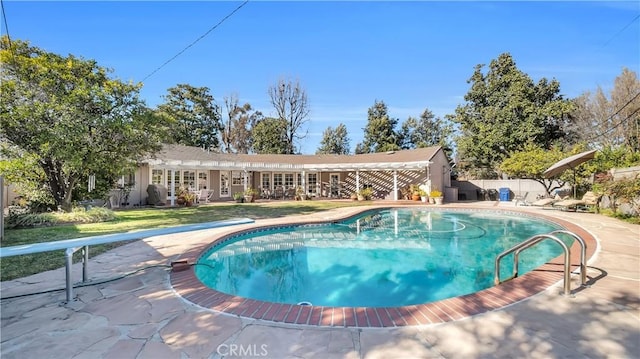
[572,68,640,151]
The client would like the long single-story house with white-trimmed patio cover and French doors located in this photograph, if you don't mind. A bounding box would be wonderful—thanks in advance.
[112,145,457,206]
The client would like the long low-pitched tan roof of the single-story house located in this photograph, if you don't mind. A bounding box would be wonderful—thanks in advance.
[142,145,441,172]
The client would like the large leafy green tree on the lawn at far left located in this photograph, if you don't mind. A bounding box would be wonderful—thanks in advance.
[0,36,165,211]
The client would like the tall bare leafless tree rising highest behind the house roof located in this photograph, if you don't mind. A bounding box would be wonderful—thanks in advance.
[268,79,309,154]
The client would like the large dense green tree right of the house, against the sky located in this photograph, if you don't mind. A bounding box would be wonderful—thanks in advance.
[449,53,573,176]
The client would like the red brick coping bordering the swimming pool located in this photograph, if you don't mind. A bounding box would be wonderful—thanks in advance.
[170,207,596,328]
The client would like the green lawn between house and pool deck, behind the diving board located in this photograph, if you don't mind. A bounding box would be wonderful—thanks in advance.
[0,201,371,281]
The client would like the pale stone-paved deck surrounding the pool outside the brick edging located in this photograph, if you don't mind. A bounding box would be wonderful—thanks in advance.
[0,202,640,359]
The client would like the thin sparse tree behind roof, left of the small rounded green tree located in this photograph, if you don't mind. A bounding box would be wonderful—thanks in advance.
[222,95,262,153]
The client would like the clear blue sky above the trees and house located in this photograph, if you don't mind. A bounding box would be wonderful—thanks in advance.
[2,0,640,153]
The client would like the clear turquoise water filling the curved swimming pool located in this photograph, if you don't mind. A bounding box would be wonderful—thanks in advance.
[195,209,572,307]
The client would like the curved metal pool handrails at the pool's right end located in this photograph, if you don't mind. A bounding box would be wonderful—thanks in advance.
[493,230,588,296]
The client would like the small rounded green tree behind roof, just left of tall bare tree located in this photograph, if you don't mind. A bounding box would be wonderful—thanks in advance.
[253,117,289,154]
